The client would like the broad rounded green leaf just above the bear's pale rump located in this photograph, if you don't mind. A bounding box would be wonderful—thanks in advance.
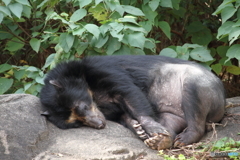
[190,47,213,62]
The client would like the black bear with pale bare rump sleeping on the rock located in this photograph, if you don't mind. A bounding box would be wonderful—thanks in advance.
[40,56,225,150]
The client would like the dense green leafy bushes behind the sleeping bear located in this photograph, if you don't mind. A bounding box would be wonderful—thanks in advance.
[0,0,240,97]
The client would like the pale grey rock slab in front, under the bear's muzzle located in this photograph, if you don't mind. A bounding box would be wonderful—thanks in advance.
[35,121,160,160]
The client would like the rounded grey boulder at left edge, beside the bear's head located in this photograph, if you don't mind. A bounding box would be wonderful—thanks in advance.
[0,94,48,160]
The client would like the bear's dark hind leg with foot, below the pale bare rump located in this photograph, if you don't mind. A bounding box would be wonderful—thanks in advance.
[174,83,206,147]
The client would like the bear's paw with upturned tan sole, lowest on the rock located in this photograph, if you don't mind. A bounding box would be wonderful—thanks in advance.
[144,133,173,150]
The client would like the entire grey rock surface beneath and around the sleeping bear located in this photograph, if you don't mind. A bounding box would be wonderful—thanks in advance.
[0,94,240,160]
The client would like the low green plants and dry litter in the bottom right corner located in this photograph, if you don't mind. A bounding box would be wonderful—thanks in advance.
[158,137,240,160]
